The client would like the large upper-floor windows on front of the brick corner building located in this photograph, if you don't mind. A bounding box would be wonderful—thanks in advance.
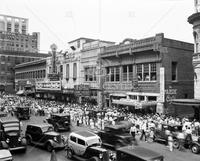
[106,63,157,82]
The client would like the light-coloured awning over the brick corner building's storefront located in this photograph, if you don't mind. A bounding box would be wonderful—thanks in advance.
[112,99,158,109]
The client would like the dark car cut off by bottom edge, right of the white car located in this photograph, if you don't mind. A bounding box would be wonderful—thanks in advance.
[115,146,164,161]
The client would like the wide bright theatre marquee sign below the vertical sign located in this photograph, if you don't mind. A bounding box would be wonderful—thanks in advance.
[35,81,61,91]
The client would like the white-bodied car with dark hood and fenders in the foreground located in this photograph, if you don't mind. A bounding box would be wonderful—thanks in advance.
[66,131,109,161]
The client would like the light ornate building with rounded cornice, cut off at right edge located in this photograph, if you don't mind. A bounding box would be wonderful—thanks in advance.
[188,0,200,99]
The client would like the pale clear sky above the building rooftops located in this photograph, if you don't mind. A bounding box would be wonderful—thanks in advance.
[0,0,194,53]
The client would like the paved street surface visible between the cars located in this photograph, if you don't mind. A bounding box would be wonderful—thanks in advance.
[13,117,200,161]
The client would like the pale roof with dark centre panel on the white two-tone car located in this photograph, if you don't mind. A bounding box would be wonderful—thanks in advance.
[70,130,99,140]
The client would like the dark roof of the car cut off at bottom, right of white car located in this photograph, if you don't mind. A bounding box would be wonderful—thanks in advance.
[117,146,163,160]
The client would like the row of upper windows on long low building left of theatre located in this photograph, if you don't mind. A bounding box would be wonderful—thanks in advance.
[15,70,46,79]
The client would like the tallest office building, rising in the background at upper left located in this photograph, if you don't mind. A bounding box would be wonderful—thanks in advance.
[0,14,40,52]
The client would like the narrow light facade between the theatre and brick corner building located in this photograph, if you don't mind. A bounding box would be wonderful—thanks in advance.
[80,40,115,104]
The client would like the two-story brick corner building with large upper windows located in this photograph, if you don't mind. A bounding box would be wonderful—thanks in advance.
[101,33,194,114]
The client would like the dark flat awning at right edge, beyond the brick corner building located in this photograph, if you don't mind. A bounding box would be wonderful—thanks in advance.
[172,99,200,106]
